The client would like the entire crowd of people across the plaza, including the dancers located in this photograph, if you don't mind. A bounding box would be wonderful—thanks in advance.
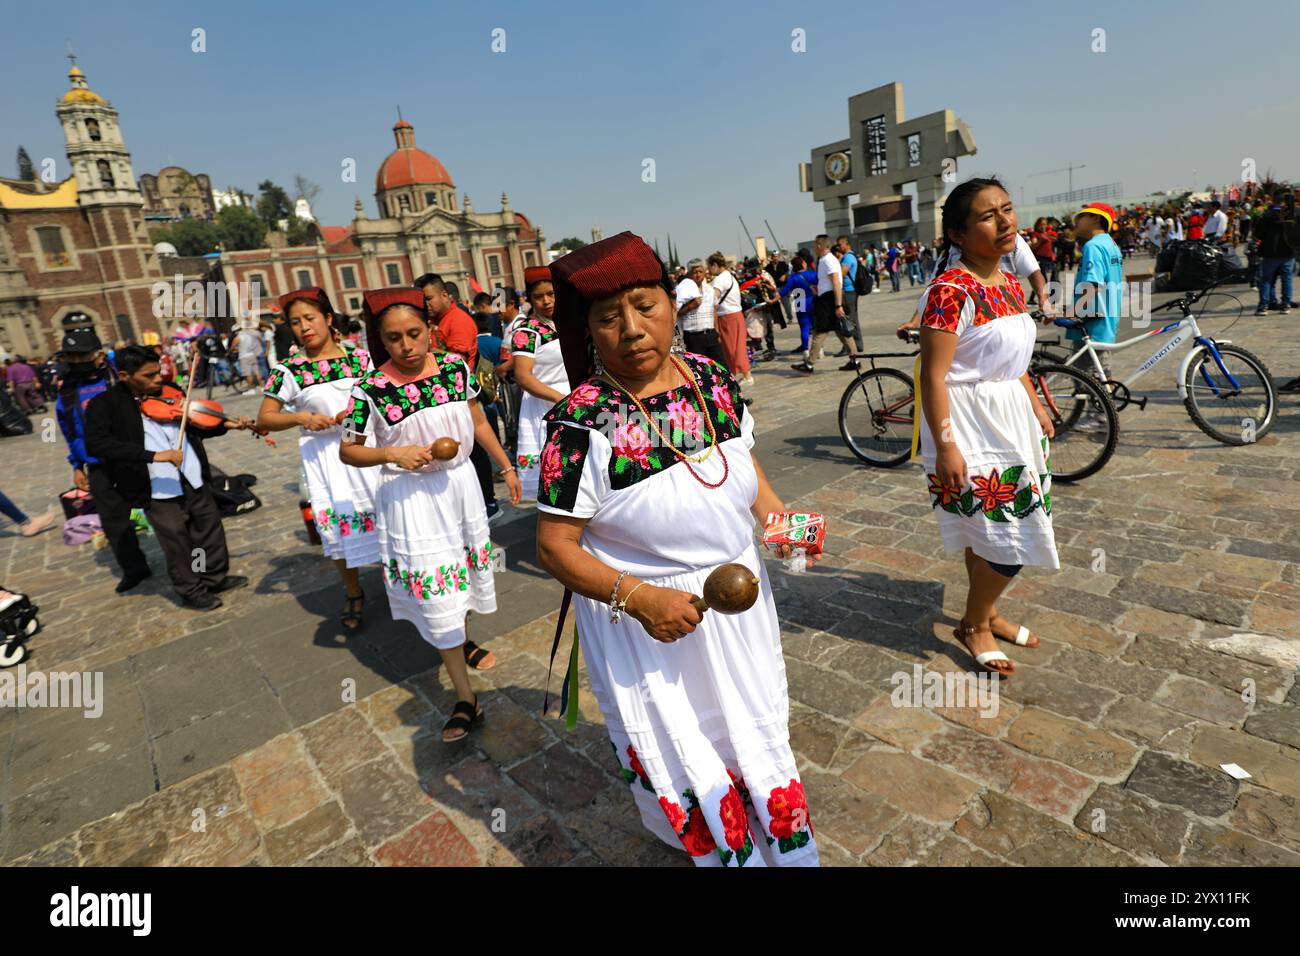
[0,170,1295,866]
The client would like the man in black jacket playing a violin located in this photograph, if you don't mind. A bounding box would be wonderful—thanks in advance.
[86,345,254,611]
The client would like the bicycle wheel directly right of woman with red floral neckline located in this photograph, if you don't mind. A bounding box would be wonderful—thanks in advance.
[1030,365,1119,483]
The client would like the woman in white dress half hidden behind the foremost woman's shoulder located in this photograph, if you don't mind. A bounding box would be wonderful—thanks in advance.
[510,265,569,498]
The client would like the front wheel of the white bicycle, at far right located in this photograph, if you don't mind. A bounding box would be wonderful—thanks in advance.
[1183,345,1278,445]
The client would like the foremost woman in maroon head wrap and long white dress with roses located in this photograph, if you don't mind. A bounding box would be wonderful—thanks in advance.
[537,233,818,866]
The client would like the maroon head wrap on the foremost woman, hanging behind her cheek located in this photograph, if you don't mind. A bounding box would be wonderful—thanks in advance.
[551,233,668,388]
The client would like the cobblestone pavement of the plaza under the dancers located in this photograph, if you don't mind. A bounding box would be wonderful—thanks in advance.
[0,270,1300,866]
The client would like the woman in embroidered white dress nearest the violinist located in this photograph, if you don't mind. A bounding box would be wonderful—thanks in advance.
[257,287,380,631]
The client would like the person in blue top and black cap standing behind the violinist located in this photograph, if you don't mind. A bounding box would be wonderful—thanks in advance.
[55,325,153,594]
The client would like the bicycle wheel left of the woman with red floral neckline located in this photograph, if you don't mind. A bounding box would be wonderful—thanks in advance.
[840,368,917,468]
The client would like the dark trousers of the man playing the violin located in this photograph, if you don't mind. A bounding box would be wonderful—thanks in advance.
[146,477,230,598]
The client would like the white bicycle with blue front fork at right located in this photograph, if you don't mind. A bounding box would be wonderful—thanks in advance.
[1054,284,1278,445]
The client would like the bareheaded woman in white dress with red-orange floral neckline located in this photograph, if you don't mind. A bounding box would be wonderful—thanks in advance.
[918,179,1060,675]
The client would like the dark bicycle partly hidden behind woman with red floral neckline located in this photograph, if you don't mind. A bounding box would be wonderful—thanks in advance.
[839,329,1119,484]
